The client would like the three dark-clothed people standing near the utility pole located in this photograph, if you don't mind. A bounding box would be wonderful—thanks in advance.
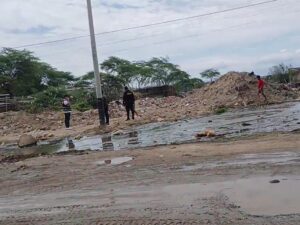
[62,87,136,129]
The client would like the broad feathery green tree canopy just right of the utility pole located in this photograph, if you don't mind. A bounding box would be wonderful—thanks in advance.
[101,57,204,91]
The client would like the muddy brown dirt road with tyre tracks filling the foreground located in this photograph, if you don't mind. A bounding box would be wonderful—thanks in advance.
[0,134,300,225]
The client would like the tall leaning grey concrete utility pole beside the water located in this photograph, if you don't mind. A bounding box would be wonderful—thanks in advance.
[87,0,105,125]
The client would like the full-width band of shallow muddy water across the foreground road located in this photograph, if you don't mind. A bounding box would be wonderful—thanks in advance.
[0,176,300,216]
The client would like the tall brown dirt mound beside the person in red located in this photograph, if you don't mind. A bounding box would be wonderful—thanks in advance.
[183,72,297,109]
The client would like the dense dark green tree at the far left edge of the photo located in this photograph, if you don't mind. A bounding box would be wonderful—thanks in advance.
[0,48,75,96]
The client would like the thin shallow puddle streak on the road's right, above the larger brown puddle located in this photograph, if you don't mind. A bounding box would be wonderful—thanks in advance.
[179,152,300,171]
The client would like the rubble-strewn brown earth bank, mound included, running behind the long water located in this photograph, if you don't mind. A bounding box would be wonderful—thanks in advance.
[0,72,299,145]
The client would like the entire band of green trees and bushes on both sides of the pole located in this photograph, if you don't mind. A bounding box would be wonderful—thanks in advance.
[0,48,204,112]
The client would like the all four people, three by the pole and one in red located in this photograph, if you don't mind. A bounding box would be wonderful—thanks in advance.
[62,72,267,129]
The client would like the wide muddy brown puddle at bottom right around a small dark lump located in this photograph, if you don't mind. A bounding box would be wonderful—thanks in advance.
[162,177,300,216]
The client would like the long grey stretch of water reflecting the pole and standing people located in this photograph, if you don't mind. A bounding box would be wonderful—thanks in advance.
[0,102,300,155]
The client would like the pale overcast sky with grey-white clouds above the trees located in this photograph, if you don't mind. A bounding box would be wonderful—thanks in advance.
[0,0,300,77]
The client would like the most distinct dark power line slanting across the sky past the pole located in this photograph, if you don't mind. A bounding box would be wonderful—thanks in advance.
[13,0,278,49]
